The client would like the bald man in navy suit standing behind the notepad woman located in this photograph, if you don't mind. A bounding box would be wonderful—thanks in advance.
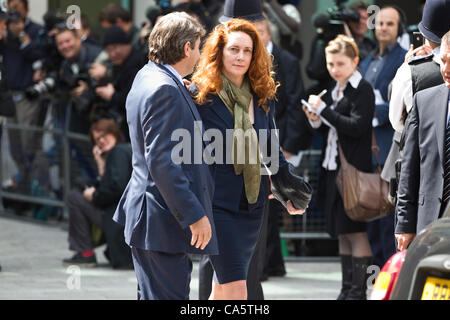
[360,5,406,268]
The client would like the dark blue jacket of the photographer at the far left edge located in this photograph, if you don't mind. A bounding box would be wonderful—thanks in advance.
[0,20,44,91]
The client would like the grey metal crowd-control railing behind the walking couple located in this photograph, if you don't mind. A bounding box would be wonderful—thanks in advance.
[0,108,330,255]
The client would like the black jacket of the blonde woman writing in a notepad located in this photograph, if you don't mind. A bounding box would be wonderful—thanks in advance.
[312,79,375,172]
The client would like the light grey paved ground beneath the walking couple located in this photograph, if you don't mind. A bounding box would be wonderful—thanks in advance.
[0,215,340,300]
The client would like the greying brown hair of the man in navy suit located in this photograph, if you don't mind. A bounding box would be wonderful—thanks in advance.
[148,12,206,65]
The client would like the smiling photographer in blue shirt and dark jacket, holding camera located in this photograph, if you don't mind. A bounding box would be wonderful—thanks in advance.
[55,27,102,134]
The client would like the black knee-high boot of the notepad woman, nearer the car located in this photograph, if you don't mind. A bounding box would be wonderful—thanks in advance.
[347,257,372,300]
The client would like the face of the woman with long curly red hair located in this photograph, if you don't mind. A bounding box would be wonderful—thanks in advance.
[222,31,253,83]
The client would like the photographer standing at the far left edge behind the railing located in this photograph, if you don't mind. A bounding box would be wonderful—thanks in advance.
[0,0,45,190]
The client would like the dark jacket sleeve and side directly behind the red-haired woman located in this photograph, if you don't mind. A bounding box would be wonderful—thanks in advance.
[272,44,313,154]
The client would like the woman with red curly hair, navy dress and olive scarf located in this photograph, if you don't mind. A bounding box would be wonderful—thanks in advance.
[188,19,304,300]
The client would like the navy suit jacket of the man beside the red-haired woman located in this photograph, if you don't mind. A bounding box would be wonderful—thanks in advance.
[114,62,218,254]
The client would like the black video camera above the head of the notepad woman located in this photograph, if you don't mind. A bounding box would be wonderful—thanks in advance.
[313,0,360,38]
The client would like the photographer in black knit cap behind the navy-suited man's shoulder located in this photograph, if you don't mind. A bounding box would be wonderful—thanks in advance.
[89,26,144,140]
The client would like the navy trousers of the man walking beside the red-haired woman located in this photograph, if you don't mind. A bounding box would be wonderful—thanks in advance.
[131,248,192,300]
